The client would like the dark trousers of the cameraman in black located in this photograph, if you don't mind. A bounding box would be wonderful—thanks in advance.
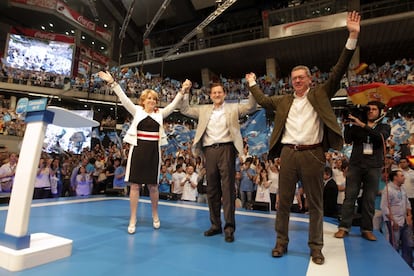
[339,165,381,232]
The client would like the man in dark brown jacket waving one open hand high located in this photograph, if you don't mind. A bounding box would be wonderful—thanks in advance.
[246,11,361,264]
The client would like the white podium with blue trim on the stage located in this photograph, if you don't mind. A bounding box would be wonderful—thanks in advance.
[0,106,99,271]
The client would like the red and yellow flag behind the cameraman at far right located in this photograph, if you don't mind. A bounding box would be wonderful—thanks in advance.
[347,82,414,107]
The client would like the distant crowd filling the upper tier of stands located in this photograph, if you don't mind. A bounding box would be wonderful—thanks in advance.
[0,54,414,137]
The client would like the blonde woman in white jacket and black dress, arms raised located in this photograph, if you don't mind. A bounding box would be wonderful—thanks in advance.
[98,71,191,234]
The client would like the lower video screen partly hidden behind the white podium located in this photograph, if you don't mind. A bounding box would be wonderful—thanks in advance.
[43,110,93,154]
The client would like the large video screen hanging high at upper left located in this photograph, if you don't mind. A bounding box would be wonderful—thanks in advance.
[5,34,75,76]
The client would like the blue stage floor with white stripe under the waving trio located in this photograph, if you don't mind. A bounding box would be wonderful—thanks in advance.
[0,197,414,276]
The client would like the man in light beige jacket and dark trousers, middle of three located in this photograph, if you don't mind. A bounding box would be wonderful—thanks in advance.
[180,83,256,242]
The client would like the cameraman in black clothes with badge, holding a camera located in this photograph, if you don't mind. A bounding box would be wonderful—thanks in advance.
[335,101,391,241]
